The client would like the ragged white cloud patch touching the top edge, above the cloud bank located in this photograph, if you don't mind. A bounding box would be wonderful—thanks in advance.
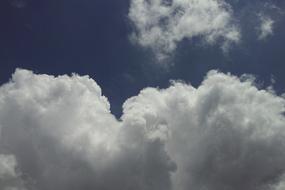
[129,0,240,59]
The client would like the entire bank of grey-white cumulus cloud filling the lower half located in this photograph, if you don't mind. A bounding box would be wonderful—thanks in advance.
[0,69,285,190]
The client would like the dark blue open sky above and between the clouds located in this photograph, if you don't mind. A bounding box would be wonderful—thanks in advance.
[0,0,285,116]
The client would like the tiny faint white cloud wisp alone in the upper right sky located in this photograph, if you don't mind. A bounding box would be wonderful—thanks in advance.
[258,14,274,40]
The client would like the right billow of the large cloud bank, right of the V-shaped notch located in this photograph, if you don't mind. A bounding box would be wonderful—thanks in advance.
[123,71,285,190]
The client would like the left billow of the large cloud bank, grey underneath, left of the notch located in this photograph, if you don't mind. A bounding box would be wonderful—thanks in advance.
[0,70,175,190]
